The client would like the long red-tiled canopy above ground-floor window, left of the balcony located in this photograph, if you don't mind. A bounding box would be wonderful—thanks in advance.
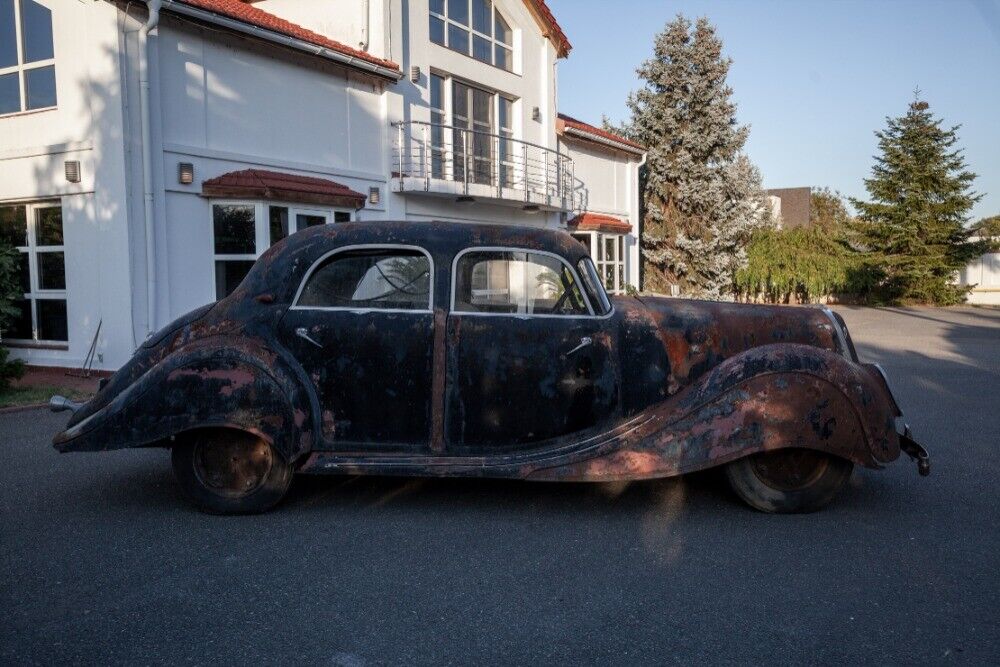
[201,169,366,208]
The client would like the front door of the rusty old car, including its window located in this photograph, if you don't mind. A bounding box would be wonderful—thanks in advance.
[445,248,619,454]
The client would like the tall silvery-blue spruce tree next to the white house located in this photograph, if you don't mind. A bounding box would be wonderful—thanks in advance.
[615,15,770,298]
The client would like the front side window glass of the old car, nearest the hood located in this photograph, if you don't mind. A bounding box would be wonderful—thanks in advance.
[452,250,590,316]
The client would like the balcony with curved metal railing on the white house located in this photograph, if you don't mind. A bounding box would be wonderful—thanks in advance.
[391,121,579,211]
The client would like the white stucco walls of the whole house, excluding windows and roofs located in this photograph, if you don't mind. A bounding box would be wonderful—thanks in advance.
[0,0,637,369]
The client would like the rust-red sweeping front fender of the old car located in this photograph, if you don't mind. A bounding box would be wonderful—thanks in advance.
[529,344,900,481]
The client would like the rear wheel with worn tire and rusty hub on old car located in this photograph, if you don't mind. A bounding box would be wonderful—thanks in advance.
[170,428,293,514]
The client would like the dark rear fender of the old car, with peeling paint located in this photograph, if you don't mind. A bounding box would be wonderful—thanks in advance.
[53,337,313,461]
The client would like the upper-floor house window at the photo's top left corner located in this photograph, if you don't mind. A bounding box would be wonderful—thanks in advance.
[0,0,56,115]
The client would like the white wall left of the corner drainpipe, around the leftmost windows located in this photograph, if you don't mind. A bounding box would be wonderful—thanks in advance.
[0,0,134,368]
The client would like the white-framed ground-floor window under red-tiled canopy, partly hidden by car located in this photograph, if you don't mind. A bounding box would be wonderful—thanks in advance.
[212,202,351,299]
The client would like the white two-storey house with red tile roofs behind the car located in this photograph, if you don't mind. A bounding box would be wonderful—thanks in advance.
[0,0,644,369]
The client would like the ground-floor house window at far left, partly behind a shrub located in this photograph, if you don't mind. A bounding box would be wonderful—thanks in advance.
[0,202,69,343]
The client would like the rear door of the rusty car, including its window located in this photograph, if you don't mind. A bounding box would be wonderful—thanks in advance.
[279,245,434,452]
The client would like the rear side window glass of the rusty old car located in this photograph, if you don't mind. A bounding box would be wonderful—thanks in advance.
[295,248,431,310]
